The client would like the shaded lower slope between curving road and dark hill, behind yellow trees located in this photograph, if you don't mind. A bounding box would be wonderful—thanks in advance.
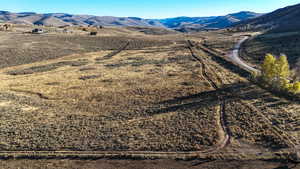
[241,31,300,79]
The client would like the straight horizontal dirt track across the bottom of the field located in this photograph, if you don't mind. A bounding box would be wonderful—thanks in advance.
[0,149,297,161]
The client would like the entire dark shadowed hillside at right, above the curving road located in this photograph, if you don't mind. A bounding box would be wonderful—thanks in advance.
[236,4,300,78]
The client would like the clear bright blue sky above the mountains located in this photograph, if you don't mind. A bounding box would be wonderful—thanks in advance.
[0,0,300,18]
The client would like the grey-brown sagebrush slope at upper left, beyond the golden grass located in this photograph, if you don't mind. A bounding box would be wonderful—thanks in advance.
[0,32,171,68]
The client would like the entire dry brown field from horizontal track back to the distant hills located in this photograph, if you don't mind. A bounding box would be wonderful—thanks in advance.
[0,25,300,167]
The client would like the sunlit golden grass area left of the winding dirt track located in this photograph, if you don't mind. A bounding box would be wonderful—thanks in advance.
[1,40,225,151]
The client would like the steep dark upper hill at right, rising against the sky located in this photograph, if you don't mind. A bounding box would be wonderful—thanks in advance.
[236,4,300,32]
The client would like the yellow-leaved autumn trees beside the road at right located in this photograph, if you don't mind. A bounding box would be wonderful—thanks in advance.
[259,54,300,94]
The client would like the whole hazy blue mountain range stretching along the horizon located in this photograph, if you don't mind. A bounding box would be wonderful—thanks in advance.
[0,11,262,31]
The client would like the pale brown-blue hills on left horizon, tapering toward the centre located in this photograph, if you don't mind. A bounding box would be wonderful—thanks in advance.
[0,11,162,27]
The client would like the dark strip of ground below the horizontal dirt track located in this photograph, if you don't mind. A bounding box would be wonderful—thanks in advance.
[0,159,300,169]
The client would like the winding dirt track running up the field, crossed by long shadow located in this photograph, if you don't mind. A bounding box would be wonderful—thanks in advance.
[187,40,231,150]
